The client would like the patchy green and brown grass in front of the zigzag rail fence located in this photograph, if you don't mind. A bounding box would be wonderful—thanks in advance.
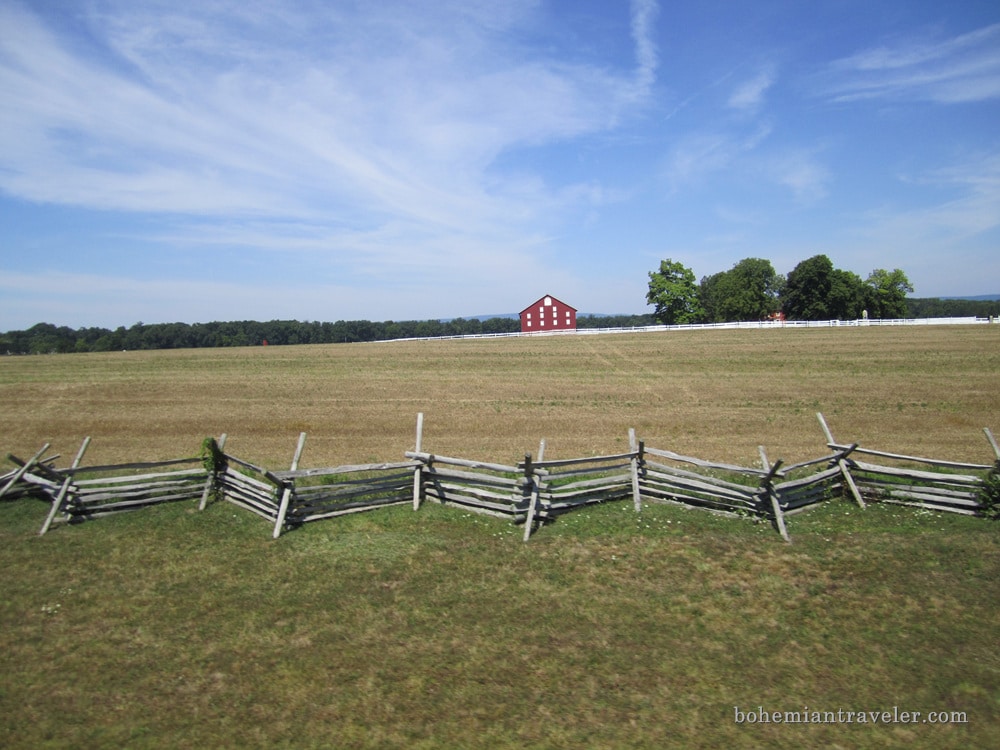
[0,500,1000,748]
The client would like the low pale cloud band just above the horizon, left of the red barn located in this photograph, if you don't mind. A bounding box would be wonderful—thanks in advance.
[0,225,560,331]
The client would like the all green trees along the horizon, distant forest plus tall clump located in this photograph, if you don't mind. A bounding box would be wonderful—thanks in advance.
[0,255,1000,354]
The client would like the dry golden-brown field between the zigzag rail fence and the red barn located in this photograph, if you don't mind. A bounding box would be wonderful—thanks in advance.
[0,326,1000,466]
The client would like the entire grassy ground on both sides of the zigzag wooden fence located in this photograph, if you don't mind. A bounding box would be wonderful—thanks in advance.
[0,326,1000,748]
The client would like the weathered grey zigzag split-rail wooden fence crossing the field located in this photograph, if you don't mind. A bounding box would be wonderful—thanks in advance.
[0,414,1000,541]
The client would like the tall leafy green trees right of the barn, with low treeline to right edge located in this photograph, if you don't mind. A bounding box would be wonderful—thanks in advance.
[646,255,1000,325]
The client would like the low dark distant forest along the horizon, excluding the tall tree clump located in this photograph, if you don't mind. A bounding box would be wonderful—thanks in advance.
[0,298,1000,354]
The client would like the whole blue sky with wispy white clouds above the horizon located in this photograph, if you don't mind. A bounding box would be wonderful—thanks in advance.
[0,0,1000,330]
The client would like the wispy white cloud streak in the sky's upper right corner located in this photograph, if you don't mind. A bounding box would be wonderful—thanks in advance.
[819,24,1000,104]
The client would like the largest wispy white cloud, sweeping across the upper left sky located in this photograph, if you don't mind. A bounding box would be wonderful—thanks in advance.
[0,0,656,248]
